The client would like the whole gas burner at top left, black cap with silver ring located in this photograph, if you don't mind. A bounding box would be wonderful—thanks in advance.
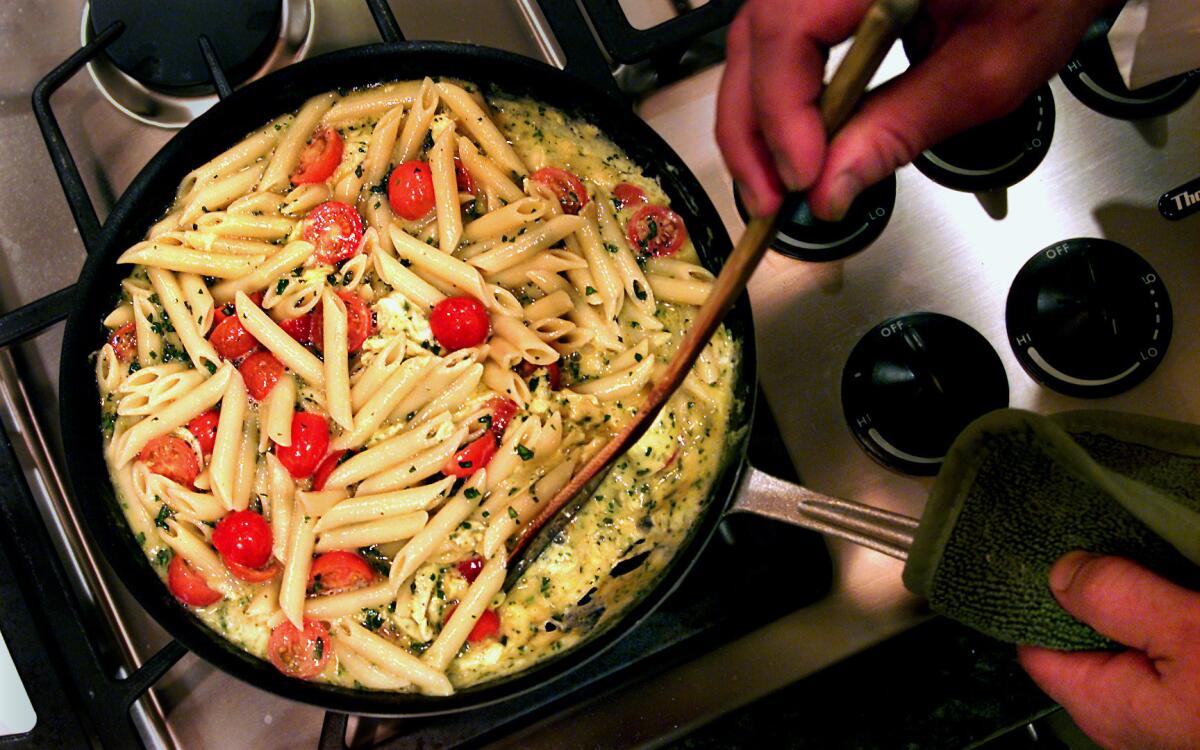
[80,0,314,128]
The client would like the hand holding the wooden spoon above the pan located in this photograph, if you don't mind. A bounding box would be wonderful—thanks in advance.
[716,0,1109,221]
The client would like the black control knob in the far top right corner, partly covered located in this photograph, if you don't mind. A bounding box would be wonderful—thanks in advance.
[1058,13,1200,120]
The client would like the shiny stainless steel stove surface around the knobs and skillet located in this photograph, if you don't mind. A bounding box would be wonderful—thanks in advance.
[0,0,1200,748]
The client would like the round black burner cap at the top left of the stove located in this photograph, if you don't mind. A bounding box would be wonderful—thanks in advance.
[89,0,283,95]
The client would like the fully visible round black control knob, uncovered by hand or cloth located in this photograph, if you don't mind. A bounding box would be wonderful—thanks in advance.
[1004,238,1171,398]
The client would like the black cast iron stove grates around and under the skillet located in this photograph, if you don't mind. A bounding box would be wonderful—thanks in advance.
[0,0,832,749]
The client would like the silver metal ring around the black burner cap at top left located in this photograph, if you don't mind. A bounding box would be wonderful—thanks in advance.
[79,0,316,130]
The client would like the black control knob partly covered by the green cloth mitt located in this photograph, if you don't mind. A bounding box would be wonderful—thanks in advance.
[841,312,1008,474]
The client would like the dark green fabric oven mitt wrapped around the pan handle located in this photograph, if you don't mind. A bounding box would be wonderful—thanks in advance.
[904,409,1200,649]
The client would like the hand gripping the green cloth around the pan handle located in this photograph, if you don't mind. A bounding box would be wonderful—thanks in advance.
[1018,552,1200,750]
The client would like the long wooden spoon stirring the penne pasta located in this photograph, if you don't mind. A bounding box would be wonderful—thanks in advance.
[504,0,919,590]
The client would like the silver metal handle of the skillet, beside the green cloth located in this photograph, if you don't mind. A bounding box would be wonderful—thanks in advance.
[728,464,917,560]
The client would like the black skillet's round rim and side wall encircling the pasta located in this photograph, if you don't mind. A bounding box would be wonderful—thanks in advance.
[59,42,756,716]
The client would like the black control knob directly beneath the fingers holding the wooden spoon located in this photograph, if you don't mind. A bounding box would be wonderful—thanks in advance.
[733,174,896,263]
